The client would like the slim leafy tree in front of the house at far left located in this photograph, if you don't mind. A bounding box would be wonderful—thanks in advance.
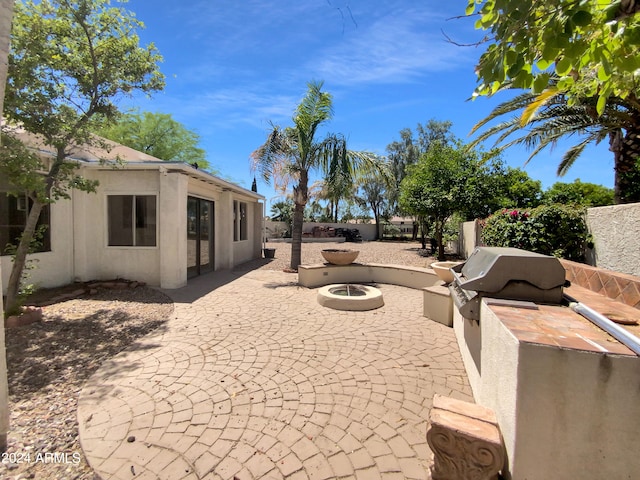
[0,0,164,312]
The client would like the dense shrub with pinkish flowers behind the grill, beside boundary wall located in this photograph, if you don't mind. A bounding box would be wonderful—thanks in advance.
[482,204,588,261]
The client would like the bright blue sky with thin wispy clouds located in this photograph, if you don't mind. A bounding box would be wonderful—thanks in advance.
[121,0,613,210]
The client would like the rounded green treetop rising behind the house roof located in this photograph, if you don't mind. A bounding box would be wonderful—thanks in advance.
[96,112,211,171]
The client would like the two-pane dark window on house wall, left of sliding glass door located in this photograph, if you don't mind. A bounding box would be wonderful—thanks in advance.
[107,195,156,247]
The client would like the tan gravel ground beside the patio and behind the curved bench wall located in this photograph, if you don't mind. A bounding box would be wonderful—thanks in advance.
[0,242,434,480]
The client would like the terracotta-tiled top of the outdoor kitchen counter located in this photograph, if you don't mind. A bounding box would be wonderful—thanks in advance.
[486,286,640,356]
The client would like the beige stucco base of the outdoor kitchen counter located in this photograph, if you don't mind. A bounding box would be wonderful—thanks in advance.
[462,304,640,480]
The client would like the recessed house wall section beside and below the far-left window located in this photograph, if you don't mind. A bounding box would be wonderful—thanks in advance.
[0,194,74,293]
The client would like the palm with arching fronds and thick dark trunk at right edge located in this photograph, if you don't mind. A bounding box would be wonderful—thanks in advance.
[470,84,640,203]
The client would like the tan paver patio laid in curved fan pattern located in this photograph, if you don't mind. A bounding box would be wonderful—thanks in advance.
[78,270,473,480]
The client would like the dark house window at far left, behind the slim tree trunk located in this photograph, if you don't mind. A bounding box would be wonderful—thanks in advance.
[0,192,51,255]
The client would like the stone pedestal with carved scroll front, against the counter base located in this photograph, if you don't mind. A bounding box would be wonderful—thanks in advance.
[427,395,505,480]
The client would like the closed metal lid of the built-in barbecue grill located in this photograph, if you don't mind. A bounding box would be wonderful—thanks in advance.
[454,247,565,293]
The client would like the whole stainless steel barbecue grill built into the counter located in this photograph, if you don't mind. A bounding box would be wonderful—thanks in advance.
[449,247,565,321]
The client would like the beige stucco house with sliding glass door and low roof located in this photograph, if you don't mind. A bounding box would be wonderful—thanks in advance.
[0,129,264,291]
